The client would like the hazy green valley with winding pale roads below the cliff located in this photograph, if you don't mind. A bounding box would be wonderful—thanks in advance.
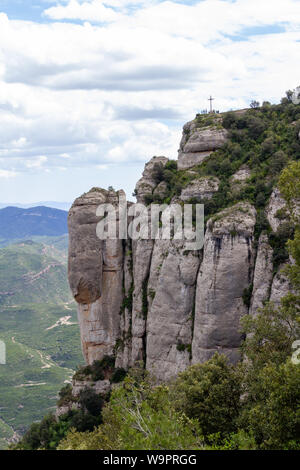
[0,236,83,449]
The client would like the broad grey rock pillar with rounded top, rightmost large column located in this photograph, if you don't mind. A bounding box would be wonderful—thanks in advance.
[192,204,256,363]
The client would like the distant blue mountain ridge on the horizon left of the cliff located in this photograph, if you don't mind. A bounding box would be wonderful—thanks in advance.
[0,206,68,243]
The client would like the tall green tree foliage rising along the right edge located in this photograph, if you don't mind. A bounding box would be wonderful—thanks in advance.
[238,198,300,450]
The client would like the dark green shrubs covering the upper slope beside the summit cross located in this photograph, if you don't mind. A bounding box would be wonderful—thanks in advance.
[145,103,300,229]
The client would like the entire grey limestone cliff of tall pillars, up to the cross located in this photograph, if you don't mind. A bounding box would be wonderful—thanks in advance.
[69,111,298,380]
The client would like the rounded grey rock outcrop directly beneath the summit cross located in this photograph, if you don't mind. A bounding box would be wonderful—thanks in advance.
[178,119,228,170]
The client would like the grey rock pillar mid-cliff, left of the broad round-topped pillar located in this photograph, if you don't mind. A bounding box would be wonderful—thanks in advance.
[146,241,200,380]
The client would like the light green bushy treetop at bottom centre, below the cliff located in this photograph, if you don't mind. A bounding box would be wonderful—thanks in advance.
[59,375,203,450]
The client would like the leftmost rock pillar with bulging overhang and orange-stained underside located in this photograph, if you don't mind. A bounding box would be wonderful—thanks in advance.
[68,189,125,364]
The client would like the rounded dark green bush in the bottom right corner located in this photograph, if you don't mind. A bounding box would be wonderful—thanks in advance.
[240,359,300,450]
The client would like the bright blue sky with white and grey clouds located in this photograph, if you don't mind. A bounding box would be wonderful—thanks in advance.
[0,0,300,203]
